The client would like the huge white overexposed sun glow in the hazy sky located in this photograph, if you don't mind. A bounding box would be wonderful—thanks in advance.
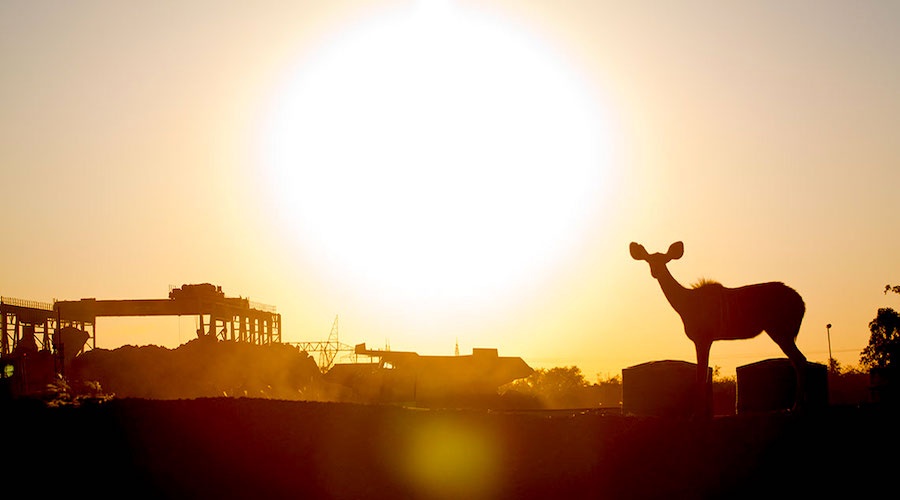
[262,2,608,307]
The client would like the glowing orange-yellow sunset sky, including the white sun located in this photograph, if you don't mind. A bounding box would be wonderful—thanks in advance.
[0,0,900,380]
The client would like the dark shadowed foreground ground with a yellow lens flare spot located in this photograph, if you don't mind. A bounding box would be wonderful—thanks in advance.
[2,398,900,498]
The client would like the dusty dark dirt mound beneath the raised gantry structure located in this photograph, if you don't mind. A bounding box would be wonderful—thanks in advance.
[67,339,321,400]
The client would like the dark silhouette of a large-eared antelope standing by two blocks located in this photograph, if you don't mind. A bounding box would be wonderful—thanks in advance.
[629,241,806,413]
